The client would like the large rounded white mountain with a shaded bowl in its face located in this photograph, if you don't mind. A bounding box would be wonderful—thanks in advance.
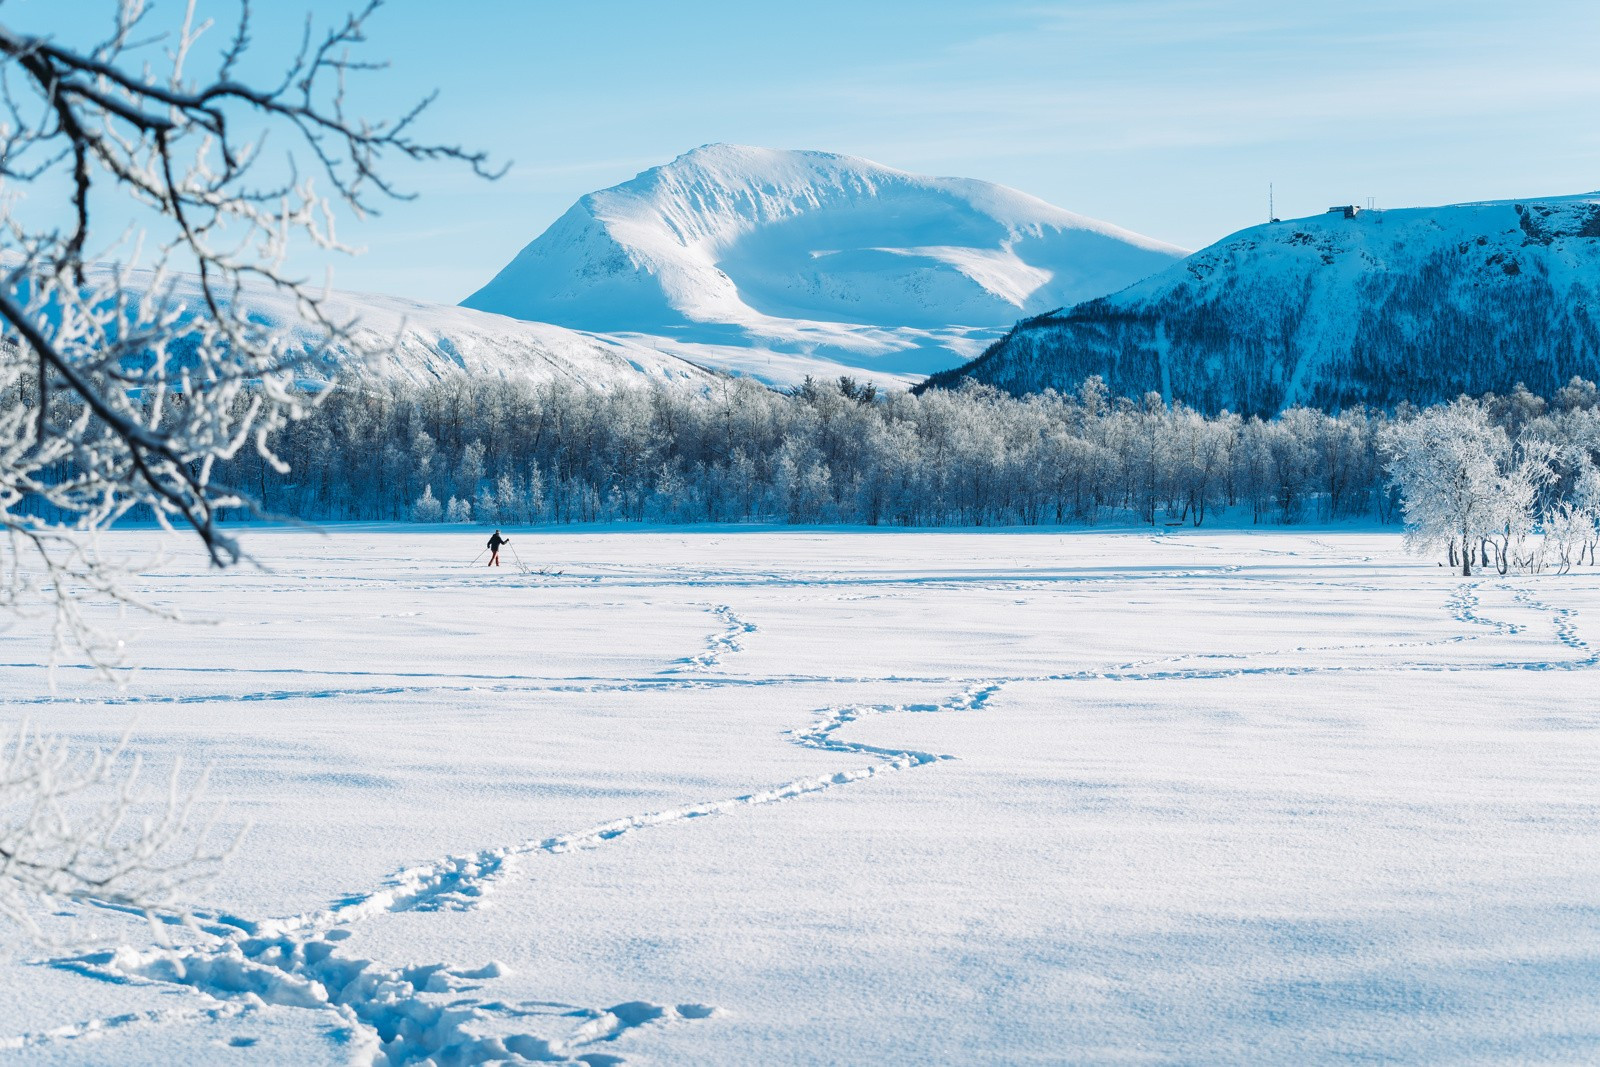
[464,144,1184,382]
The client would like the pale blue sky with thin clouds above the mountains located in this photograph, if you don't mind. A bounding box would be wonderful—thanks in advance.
[21,0,1600,302]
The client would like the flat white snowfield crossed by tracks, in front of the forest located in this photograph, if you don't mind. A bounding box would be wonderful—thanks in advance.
[0,525,1600,1064]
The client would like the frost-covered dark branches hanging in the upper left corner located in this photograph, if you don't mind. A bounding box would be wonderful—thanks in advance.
[0,0,486,662]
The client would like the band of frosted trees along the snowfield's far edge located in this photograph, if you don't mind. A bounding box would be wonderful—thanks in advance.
[222,378,1600,550]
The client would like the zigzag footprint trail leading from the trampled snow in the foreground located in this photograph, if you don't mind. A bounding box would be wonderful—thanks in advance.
[28,681,1005,1067]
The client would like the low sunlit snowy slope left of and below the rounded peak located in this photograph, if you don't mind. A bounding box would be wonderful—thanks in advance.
[128,273,714,389]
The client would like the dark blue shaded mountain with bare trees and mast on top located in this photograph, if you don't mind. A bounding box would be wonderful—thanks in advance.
[930,194,1600,413]
